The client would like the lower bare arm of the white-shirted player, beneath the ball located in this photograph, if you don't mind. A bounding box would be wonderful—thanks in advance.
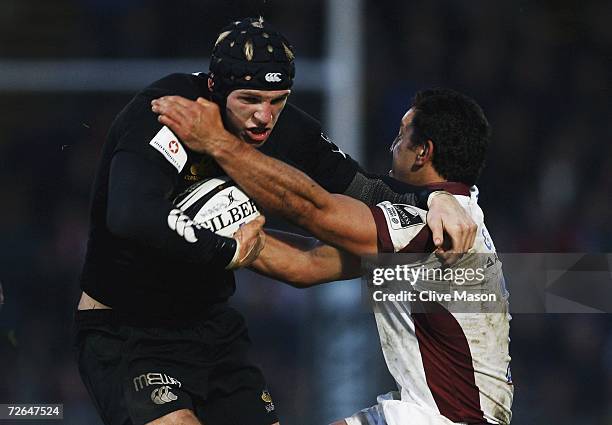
[251,230,361,288]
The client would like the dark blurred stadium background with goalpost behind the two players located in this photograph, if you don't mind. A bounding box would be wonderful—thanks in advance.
[0,0,612,425]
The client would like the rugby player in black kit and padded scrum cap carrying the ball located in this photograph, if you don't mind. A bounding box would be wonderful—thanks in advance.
[75,19,476,425]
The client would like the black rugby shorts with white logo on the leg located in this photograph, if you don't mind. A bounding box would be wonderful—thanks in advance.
[75,304,278,425]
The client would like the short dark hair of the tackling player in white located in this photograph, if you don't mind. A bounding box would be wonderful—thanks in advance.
[411,88,491,186]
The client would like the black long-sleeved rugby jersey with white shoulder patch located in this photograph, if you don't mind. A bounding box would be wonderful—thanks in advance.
[81,74,360,319]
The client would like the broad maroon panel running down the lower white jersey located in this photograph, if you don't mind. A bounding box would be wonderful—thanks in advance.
[412,302,486,424]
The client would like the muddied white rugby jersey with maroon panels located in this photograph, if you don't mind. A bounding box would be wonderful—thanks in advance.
[371,183,513,424]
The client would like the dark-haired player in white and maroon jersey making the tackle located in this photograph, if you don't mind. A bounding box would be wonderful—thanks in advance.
[155,89,513,425]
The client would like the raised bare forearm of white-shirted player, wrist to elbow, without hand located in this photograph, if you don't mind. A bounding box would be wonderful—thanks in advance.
[211,137,330,229]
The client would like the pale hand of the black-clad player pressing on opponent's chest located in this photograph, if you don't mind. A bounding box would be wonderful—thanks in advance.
[427,193,478,264]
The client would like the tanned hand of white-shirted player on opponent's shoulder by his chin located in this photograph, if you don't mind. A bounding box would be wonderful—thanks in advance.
[151,96,231,153]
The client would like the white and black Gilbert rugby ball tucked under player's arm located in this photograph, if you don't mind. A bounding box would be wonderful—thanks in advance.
[174,176,260,237]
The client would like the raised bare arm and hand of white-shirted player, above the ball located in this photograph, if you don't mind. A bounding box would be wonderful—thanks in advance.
[154,96,378,255]
